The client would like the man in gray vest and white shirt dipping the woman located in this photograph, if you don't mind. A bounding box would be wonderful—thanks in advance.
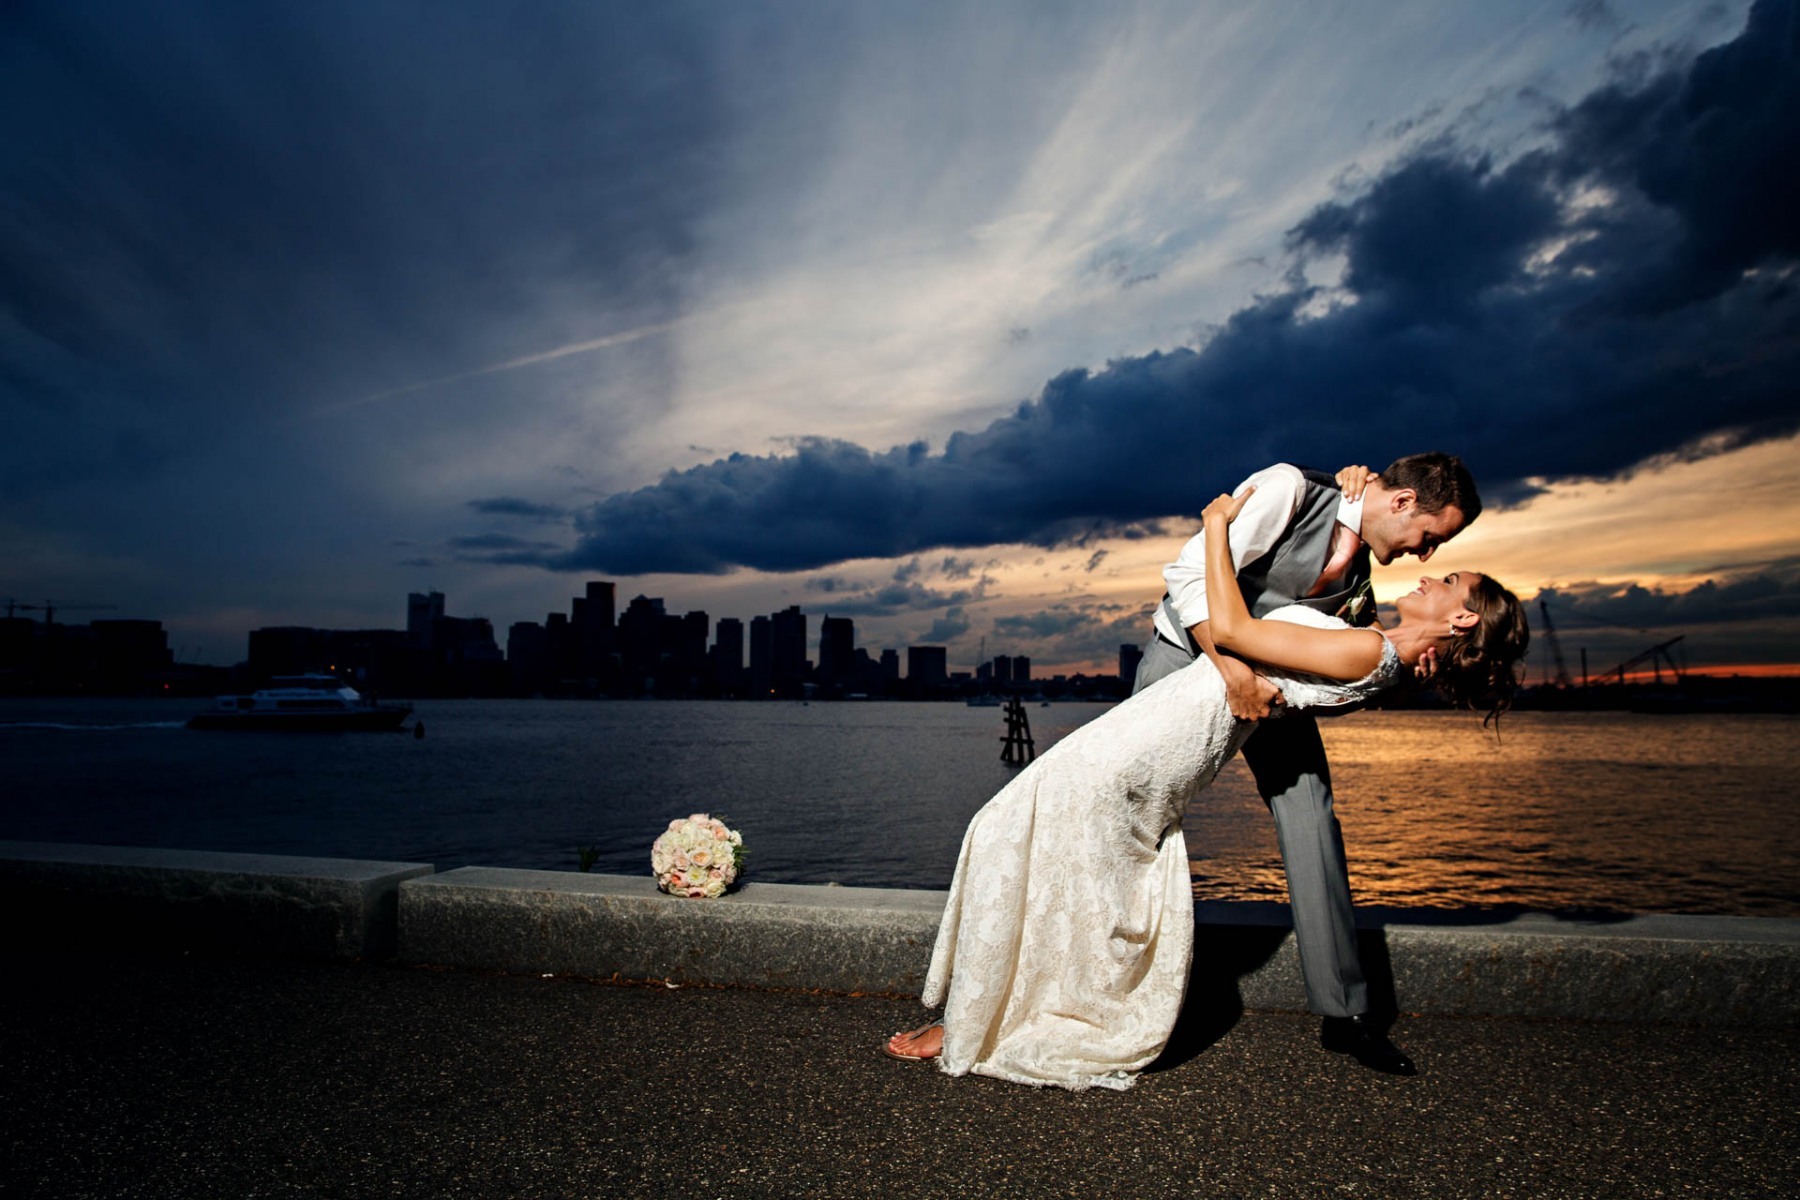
[1132,453,1481,1076]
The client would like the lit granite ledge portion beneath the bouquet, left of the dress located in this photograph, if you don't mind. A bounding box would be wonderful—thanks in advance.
[400,867,943,993]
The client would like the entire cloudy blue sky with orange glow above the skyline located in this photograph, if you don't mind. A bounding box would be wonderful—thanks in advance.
[0,0,1800,667]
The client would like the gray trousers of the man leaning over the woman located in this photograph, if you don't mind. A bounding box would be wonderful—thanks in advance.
[1132,637,1368,1016]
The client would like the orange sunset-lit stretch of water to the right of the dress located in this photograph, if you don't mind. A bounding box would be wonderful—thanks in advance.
[1186,712,1800,916]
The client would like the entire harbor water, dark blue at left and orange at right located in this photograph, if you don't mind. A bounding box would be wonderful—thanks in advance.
[0,698,1800,918]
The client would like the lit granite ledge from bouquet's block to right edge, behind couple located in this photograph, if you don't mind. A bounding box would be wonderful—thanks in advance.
[400,867,1800,1025]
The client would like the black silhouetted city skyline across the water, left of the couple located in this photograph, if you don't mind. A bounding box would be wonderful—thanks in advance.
[0,579,1072,700]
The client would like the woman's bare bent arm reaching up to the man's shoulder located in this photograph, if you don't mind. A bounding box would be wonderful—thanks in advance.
[1204,491,1381,682]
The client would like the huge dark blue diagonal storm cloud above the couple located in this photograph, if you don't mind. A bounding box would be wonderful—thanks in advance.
[540,0,1800,574]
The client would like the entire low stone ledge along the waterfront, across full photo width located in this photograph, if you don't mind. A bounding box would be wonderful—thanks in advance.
[14,842,1800,1025]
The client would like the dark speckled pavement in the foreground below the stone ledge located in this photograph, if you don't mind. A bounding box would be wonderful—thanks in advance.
[0,959,1800,1200]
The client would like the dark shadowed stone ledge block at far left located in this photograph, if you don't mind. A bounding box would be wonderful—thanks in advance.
[0,842,432,959]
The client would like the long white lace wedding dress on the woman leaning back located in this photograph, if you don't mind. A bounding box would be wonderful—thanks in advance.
[923,606,1400,1090]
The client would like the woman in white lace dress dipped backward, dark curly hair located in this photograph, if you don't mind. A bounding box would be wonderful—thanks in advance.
[884,489,1528,1090]
